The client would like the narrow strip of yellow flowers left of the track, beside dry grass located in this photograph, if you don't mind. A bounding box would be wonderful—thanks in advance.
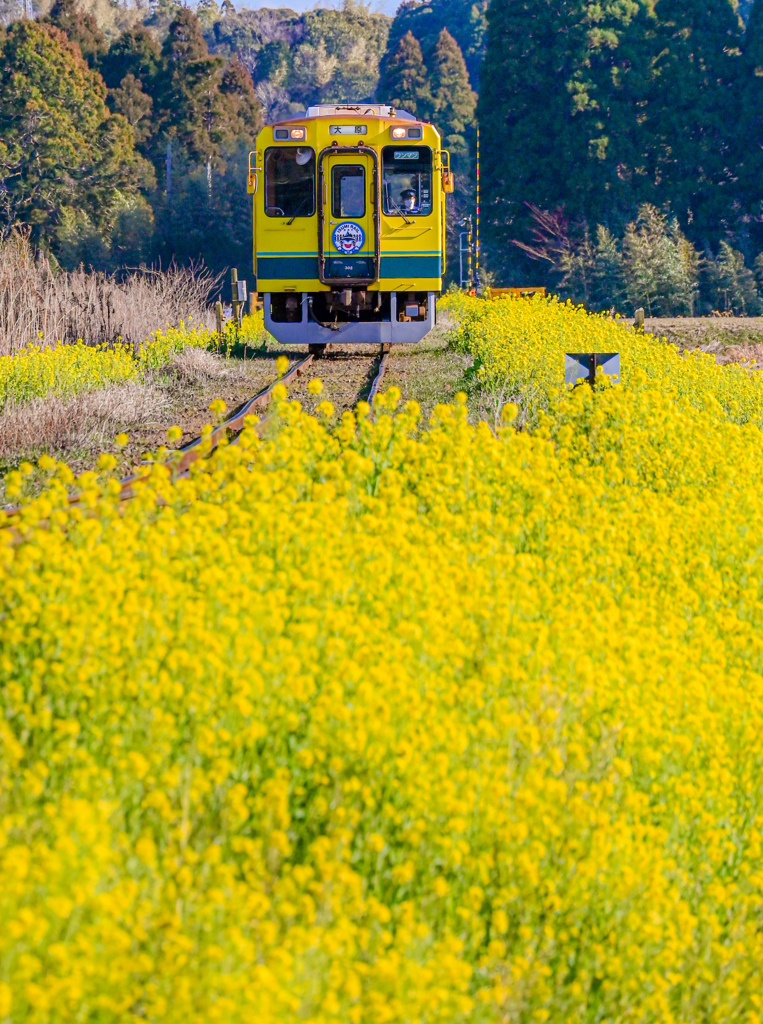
[0,310,266,410]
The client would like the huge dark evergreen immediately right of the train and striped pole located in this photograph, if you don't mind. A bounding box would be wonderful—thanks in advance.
[478,0,654,278]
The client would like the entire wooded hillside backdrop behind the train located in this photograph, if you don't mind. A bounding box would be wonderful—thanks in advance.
[0,0,763,313]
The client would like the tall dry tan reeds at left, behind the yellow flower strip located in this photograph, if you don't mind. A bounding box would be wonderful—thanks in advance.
[0,234,219,355]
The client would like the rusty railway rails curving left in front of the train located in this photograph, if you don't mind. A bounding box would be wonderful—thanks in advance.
[5,345,389,526]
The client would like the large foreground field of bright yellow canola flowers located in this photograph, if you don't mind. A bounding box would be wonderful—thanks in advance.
[0,299,763,1024]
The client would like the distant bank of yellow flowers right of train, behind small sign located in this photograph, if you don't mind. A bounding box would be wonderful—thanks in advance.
[439,295,763,426]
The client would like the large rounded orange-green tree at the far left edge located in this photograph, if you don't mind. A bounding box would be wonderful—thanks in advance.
[0,22,153,241]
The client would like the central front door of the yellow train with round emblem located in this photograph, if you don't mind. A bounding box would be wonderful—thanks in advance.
[319,146,379,288]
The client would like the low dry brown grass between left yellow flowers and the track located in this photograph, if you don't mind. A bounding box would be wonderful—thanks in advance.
[0,382,167,461]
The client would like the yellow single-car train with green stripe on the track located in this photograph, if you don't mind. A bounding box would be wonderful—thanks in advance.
[248,103,453,346]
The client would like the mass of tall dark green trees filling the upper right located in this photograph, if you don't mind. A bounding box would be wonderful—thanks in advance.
[478,0,760,280]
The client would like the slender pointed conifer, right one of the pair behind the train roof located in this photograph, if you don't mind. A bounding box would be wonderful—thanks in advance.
[429,29,477,158]
